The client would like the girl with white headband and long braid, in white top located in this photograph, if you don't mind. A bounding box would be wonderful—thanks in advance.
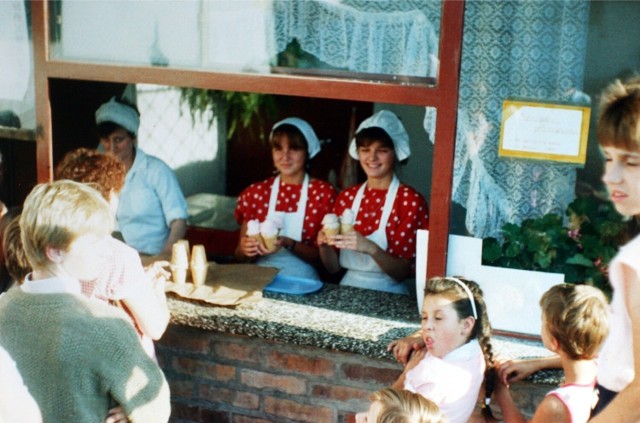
[393,277,493,423]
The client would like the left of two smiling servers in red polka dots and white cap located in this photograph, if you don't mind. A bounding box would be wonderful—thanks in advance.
[235,117,336,280]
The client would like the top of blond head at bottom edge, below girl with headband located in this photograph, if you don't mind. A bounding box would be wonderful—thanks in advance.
[371,388,447,423]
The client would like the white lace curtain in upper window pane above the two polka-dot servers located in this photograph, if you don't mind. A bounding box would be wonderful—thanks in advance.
[273,0,440,77]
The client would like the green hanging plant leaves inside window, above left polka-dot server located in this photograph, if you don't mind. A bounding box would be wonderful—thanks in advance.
[180,88,277,141]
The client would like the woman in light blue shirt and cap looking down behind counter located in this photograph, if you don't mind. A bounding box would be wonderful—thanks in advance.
[96,97,188,255]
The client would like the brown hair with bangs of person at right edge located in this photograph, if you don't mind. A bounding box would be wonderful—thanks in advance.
[597,77,640,151]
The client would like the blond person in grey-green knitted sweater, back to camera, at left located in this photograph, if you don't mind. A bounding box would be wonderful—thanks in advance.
[0,181,171,423]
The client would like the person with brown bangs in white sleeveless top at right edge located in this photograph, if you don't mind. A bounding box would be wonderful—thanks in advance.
[499,77,640,423]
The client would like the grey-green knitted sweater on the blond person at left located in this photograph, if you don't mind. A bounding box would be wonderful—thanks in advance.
[0,287,171,423]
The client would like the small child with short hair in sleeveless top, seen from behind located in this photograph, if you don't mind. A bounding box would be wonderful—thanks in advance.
[495,284,609,423]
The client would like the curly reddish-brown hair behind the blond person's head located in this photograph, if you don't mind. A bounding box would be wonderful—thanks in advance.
[55,148,126,201]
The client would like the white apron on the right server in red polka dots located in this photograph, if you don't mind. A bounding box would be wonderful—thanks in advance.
[340,175,409,294]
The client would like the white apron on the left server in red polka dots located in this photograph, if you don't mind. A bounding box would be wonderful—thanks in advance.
[256,174,320,280]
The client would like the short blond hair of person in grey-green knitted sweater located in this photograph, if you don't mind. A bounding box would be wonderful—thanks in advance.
[20,180,113,270]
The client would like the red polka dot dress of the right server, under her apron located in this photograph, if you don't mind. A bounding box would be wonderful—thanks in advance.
[334,184,429,259]
